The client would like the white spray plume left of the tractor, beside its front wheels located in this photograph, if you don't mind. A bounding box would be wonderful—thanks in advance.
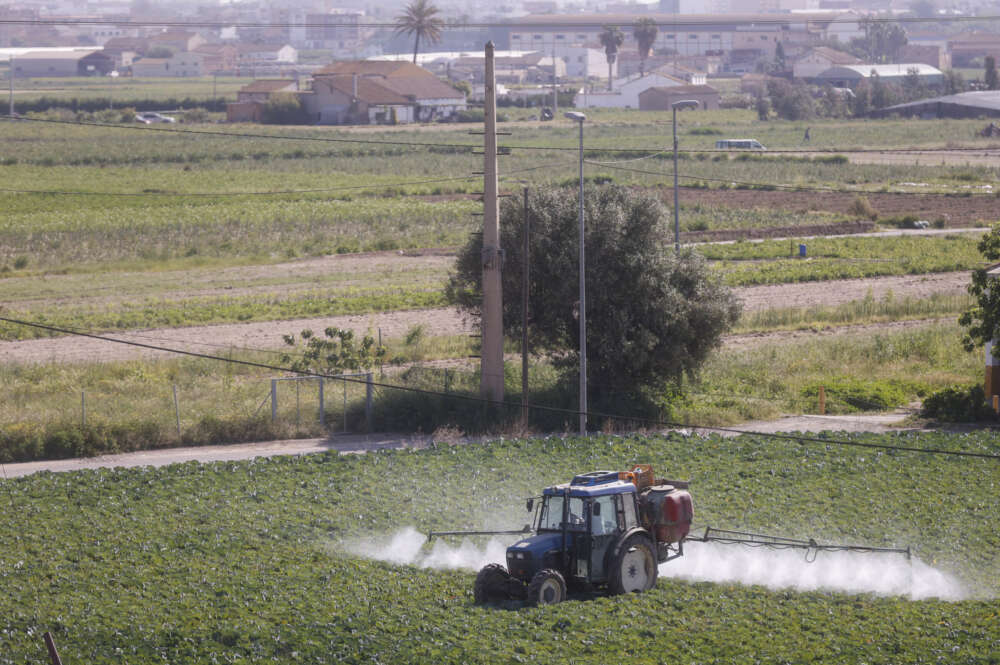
[341,527,514,570]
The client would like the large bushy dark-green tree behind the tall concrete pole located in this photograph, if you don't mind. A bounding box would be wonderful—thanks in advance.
[447,186,740,403]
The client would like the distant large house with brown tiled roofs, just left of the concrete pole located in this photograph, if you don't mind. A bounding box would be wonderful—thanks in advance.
[302,60,467,124]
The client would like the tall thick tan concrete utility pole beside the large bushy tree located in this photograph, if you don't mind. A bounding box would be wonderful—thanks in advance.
[479,42,503,402]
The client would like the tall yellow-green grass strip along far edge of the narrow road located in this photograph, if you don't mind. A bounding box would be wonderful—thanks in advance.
[0,324,981,460]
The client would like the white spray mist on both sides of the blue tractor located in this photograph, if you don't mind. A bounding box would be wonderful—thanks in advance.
[337,527,972,601]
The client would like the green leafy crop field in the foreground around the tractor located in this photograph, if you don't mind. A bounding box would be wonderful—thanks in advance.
[0,434,1000,665]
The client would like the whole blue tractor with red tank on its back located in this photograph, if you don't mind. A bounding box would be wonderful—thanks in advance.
[464,465,691,605]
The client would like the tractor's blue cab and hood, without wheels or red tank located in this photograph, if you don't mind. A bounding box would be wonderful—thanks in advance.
[507,471,639,585]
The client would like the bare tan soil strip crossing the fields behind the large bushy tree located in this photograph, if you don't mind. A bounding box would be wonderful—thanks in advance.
[0,272,969,364]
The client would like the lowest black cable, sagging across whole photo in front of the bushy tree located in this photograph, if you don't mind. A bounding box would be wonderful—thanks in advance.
[0,317,1000,461]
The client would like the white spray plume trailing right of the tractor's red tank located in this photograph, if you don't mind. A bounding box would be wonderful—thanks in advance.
[660,542,971,600]
